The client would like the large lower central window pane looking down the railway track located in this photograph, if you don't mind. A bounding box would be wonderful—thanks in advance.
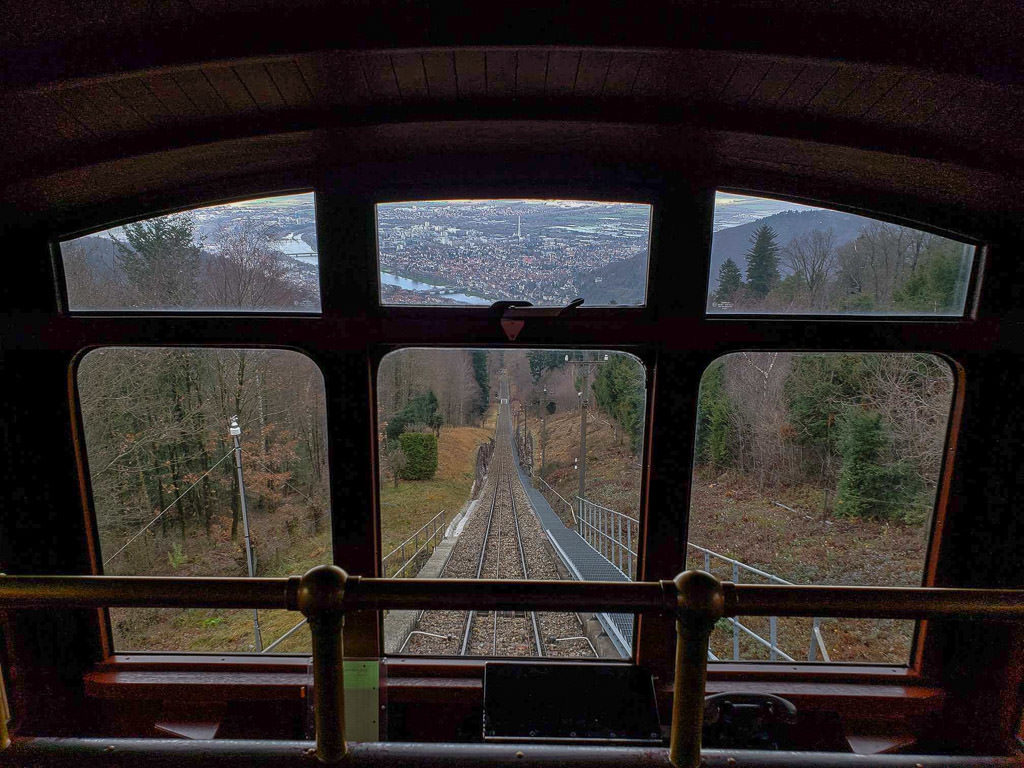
[377,349,646,658]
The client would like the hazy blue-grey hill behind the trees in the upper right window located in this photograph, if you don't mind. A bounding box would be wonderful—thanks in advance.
[711,211,866,291]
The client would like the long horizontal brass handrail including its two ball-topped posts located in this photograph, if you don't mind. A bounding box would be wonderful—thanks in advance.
[0,565,1024,768]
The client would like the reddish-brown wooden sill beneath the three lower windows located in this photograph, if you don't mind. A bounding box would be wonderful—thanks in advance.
[85,654,945,722]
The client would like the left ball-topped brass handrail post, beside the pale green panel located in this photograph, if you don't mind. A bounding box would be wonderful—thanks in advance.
[297,565,349,763]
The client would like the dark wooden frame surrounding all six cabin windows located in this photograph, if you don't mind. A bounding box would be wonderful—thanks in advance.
[0,150,1024,753]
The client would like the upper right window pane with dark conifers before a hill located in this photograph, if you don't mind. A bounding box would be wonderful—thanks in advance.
[708,193,975,316]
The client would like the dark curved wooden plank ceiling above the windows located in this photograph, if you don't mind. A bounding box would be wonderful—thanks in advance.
[0,0,1024,225]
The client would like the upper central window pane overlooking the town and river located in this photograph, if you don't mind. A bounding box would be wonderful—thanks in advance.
[377,200,651,306]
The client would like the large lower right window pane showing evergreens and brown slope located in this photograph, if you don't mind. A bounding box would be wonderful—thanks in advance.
[686,352,953,665]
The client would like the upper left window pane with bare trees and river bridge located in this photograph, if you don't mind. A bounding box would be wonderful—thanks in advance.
[60,193,321,312]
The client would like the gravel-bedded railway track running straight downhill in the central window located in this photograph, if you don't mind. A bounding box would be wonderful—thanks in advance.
[402,386,597,657]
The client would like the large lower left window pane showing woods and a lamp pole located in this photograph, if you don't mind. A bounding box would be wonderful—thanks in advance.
[78,347,331,652]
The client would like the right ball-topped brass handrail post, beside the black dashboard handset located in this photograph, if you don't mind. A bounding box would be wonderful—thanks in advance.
[669,570,725,768]
